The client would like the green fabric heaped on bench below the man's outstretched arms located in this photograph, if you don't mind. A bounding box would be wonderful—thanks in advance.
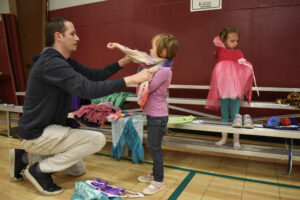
[91,92,136,109]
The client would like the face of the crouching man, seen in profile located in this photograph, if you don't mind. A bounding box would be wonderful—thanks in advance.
[61,21,79,53]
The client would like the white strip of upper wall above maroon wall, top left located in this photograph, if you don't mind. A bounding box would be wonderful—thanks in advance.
[48,0,106,11]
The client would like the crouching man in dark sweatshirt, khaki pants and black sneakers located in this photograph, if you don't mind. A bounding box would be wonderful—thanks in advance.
[10,17,152,195]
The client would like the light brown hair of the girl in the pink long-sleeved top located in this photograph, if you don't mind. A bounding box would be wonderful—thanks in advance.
[152,34,178,60]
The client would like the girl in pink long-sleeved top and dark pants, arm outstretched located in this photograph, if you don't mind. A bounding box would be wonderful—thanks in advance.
[108,34,178,194]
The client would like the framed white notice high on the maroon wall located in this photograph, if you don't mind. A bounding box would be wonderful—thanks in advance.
[191,0,222,12]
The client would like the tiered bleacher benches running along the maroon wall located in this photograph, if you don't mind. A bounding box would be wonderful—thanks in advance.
[0,85,300,173]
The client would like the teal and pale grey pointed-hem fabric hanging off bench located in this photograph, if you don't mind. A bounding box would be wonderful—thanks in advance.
[111,115,144,163]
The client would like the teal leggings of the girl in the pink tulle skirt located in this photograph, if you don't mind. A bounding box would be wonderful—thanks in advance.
[219,98,240,122]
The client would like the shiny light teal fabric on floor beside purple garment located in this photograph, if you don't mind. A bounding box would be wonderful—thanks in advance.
[71,181,122,200]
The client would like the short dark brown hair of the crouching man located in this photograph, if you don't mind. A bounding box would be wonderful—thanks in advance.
[45,17,72,47]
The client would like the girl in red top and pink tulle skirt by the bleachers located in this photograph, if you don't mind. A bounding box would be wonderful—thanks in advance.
[205,27,255,149]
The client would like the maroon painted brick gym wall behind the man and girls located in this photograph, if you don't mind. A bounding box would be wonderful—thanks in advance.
[49,0,300,117]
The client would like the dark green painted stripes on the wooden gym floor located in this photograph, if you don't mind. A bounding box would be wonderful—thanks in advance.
[96,153,300,191]
